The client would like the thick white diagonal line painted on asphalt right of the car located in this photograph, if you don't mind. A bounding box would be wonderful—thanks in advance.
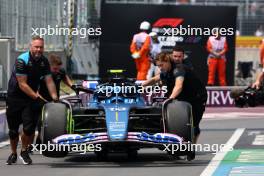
[200,128,245,176]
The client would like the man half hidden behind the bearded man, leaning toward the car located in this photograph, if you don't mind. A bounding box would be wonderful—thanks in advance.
[33,54,75,146]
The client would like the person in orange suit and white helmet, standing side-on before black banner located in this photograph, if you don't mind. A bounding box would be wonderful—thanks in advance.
[130,21,151,80]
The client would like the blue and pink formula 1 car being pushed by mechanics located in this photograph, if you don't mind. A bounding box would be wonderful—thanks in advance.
[41,71,195,160]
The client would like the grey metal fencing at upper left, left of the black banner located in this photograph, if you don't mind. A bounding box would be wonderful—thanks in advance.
[0,0,100,75]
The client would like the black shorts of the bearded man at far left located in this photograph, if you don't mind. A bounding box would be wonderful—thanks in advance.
[6,97,40,135]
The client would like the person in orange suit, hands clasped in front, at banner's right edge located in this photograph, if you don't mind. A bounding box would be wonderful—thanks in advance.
[207,31,227,86]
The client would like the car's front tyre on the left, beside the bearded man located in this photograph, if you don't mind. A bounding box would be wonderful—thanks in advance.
[41,103,68,157]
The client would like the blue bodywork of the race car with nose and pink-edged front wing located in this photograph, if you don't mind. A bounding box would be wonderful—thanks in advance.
[53,81,183,144]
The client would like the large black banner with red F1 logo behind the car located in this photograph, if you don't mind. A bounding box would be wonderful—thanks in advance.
[99,3,237,85]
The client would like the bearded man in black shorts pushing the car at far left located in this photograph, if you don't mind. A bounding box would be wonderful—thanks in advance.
[6,36,58,165]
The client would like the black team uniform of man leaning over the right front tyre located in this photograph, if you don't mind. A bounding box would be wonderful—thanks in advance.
[160,63,207,135]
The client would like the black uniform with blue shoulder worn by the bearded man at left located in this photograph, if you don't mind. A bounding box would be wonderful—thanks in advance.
[6,52,50,139]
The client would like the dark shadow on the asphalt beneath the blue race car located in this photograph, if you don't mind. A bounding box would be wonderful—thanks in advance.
[48,153,210,168]
